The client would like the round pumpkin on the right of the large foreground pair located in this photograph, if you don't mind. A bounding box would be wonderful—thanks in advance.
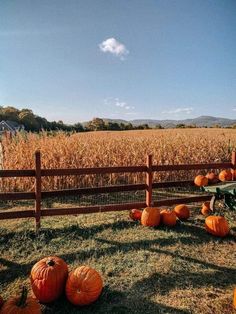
[66,266,103,305]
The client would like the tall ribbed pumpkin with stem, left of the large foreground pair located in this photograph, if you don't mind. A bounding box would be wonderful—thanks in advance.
[30,256,68,303]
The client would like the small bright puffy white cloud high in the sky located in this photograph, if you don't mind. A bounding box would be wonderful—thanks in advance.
[99,37,129,60]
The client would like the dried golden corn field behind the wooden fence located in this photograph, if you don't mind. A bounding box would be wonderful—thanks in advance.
[1,129,236,191]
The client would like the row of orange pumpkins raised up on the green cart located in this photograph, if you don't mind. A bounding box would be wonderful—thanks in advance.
[194,169,236,186]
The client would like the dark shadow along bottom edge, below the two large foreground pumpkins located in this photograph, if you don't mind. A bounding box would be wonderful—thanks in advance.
[42,286,190,314]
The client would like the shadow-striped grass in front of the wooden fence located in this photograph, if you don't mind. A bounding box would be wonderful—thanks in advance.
[0,207,236,314]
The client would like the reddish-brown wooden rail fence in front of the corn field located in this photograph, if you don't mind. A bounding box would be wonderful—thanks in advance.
[0,151,236,231]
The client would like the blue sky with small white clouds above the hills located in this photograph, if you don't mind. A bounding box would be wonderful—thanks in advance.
[0,0,236,123]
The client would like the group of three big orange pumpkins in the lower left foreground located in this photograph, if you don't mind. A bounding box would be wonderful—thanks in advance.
[0,256,103,314]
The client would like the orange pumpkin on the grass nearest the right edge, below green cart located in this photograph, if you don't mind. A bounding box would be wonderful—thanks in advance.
[205,216,229,237]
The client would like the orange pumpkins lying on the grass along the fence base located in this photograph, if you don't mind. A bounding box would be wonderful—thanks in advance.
[129,202,230,237]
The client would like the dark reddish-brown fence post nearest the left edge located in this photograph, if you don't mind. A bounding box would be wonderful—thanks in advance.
[35,150,42,233]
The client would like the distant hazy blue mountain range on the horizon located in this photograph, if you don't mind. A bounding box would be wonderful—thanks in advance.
[98,116,236,128]
